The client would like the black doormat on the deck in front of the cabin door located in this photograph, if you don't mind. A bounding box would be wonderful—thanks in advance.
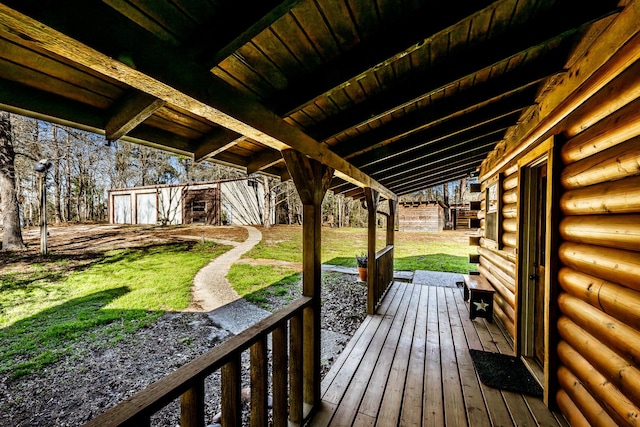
[469,349,542,397]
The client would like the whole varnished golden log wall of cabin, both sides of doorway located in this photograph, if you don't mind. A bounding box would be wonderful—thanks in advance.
[479,6,640,426]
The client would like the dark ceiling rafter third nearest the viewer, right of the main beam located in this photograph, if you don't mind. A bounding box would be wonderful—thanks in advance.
[304,8,616,141]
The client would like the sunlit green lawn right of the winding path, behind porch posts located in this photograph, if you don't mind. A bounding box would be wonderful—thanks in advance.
[227,225,475,303]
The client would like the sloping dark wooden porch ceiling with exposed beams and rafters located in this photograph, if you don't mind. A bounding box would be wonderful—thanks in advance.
[0,0,618,197]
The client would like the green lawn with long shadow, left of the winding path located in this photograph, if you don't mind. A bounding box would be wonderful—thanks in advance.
[0,243,228,376]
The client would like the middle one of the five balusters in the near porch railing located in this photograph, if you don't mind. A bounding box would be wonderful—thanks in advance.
[250,335,269,427]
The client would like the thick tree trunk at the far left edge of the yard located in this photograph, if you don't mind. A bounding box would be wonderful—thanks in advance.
[0,112,26,251]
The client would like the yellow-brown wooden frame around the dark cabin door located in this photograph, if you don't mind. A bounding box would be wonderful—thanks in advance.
[514,136,562,409]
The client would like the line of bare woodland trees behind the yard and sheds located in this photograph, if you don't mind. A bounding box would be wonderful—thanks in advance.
[0,112,476,249]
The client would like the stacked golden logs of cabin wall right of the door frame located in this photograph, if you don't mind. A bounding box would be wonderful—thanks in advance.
[557,62,640,426]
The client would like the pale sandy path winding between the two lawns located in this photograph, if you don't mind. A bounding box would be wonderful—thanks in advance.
[185,226,262,312]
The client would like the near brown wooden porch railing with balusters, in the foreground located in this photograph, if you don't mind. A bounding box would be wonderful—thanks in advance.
[84,297,313,427]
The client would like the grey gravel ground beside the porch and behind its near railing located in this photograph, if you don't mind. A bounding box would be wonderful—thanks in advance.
[0,274,366,427]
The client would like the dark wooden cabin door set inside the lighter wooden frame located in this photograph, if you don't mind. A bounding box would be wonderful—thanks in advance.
[520,160,548,370]
